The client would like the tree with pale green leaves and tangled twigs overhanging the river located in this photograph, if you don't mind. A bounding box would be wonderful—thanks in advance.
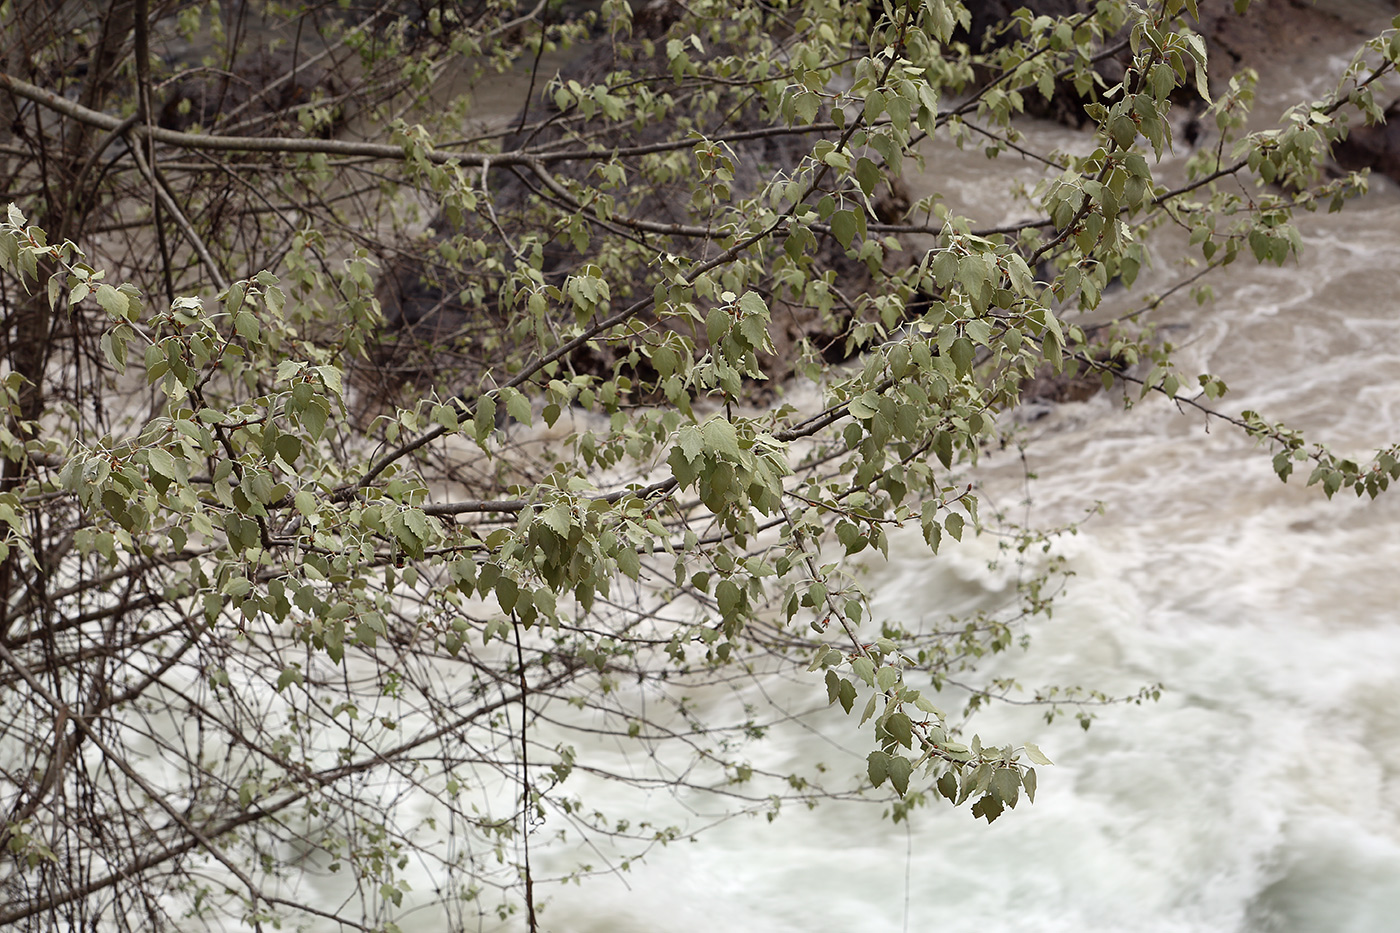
[0,0,1400,929]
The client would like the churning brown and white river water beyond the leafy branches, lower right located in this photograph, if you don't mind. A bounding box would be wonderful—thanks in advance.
[534,21,1400,933]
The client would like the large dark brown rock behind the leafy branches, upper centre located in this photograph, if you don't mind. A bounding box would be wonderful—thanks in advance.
[375,22,913,401]
